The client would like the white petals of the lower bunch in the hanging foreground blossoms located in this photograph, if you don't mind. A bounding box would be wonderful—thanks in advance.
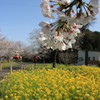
[39,22,82,51]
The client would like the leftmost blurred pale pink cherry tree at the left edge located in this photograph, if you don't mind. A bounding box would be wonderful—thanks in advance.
[0,36,23,61]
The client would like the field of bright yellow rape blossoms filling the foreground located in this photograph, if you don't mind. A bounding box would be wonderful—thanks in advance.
[0,65,100,100]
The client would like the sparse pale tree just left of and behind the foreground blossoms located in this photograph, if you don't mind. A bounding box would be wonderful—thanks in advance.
[29,29,50,59]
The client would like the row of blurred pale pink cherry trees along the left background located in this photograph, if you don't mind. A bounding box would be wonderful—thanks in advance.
[0,33,33,61]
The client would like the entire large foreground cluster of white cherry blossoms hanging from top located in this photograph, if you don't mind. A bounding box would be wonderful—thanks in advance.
[39,0,98,51]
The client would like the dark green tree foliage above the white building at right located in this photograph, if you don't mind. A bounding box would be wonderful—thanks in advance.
[81,30,100,51]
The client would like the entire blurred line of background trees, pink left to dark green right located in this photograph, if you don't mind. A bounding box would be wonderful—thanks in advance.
[0,29,100,64]
